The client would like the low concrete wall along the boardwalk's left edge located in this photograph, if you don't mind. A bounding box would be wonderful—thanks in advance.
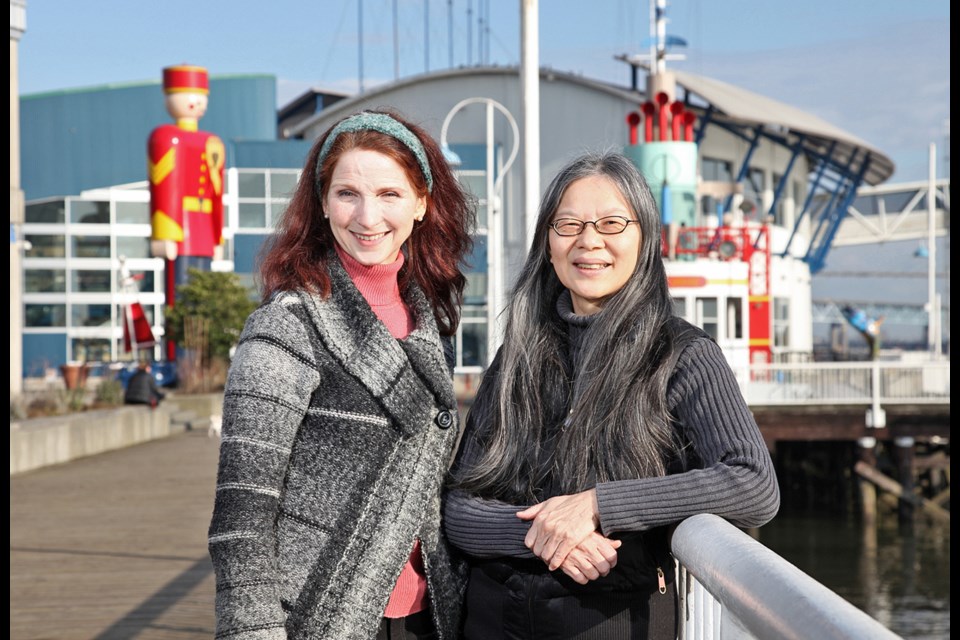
[10,394,223,475]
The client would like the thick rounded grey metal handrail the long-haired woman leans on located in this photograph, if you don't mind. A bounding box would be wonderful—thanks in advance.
[671,514,899,640]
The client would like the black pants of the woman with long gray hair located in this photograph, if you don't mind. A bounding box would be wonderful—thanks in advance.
[464,569,678,640]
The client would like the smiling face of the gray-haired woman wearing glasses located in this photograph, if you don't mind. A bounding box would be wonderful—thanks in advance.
[547,176,641,315]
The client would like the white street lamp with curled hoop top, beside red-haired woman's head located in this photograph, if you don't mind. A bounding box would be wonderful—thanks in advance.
[440,98,520,362]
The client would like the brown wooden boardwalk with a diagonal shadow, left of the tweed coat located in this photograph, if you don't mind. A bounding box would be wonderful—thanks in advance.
[10,430,219,640]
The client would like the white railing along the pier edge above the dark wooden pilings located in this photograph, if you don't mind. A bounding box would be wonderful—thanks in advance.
[734,360,950,406]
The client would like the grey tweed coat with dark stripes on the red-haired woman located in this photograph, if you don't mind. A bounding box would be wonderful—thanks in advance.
[209,257,466,640]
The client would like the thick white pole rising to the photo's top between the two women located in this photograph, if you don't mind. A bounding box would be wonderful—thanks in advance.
[520,0,540,249]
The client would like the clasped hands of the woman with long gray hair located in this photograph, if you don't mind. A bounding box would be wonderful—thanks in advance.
[517,489,623,584]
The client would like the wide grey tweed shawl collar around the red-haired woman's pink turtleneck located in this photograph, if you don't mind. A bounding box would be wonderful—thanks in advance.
[299,252,457,435]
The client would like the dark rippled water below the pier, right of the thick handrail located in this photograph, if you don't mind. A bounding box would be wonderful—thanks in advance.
[758,514,950,640]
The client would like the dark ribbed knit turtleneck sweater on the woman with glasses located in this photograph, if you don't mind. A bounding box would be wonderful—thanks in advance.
[444,296,780,571]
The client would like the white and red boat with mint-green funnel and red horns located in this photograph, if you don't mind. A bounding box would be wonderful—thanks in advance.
[624,0,788,371]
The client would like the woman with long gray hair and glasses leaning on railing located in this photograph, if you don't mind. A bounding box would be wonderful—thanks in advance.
[444,153,780,640]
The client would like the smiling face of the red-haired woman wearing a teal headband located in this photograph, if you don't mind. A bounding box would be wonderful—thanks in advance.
[323,148,427,266]
